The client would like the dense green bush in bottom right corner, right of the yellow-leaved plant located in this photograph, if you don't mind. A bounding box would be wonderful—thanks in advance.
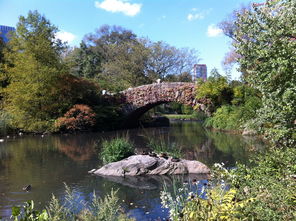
[229,148,296,221]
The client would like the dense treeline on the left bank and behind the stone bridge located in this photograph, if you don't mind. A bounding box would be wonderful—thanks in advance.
[0,11,198,132]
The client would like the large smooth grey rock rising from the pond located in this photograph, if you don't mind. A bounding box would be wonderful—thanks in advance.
[91,155,210,176]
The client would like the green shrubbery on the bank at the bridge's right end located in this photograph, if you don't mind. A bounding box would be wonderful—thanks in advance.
[196,77,261,130]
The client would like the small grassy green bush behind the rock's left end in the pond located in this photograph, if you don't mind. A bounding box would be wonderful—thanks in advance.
[100,137,134,164]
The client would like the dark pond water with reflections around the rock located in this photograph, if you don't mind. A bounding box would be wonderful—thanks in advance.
[0,122,264,221]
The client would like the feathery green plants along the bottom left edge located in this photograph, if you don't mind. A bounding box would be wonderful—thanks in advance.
[12,186,134,221]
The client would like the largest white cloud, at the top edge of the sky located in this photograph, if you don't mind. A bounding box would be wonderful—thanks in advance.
[95,0,142,16]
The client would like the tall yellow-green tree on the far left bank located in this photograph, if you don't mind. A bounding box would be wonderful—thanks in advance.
[4,11,66,131]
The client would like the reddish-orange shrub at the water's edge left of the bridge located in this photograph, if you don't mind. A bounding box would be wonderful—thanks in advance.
[56,104,96,131]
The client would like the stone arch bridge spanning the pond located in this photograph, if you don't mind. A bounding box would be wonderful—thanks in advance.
[121,82,209,128]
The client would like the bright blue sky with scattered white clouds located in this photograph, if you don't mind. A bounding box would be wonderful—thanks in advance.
[0,0,263,79]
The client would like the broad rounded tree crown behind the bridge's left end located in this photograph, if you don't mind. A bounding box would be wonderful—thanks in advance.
[67,25,148,91]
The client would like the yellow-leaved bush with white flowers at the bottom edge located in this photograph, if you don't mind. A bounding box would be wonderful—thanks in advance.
[160,175,253,221]
